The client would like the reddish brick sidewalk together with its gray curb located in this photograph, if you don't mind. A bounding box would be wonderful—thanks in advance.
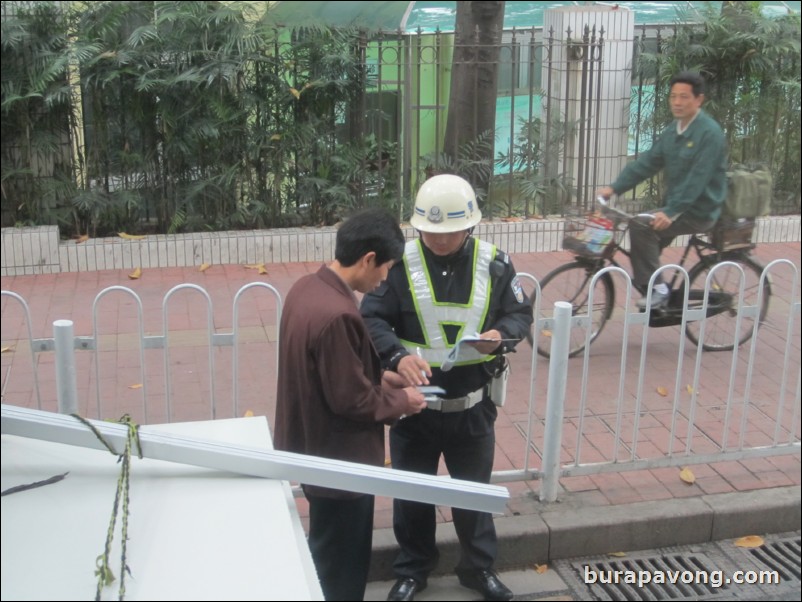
[0,242,802,599]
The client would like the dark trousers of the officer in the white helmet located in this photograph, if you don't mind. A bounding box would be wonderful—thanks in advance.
[390,400,498,584]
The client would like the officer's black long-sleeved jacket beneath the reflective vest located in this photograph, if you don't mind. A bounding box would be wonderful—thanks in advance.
[361,237,532,397]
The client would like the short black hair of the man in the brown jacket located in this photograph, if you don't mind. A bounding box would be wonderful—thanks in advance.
[334,208,404,268]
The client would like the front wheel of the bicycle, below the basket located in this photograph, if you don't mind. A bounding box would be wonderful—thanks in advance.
[535,261,615,357]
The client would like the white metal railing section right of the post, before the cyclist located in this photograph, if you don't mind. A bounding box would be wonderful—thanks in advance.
[541,259,800,501]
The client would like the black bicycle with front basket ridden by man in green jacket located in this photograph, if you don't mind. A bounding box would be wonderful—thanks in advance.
[537,198,771,357]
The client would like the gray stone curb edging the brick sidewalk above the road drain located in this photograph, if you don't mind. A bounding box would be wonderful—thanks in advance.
[369,486,802,581]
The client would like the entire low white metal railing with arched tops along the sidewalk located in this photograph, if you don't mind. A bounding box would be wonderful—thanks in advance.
[2,259,800,501]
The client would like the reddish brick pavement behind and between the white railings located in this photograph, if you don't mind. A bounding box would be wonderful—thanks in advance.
[0,243,801,528]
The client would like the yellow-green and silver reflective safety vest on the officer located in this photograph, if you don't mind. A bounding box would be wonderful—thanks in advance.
[401,240,496,367]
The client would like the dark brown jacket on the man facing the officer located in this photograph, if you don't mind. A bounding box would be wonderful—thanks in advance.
[274,266,406,497]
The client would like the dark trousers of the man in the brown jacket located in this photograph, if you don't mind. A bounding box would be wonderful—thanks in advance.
[306,495,373,600]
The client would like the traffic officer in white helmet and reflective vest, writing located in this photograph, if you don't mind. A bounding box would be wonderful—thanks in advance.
[361,175,532,600]
